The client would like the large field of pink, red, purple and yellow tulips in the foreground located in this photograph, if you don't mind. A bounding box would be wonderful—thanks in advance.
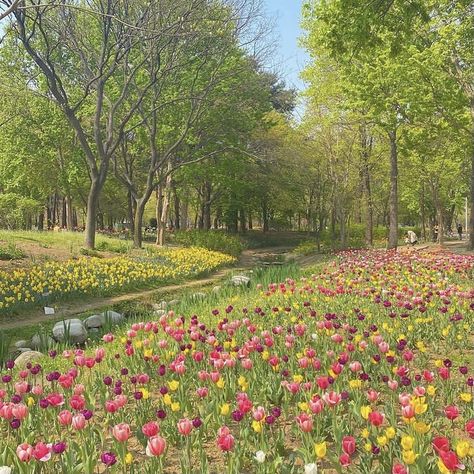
[0,251,474,474]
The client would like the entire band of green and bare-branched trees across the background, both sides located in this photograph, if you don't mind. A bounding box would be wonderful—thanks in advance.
[0,0,474,247]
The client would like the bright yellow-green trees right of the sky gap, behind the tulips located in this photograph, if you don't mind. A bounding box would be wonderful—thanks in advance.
[303,0,474,247]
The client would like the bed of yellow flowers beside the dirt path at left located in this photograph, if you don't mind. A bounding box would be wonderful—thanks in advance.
[0,248,235,311]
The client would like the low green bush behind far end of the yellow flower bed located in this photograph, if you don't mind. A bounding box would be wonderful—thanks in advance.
[175,230,245,257]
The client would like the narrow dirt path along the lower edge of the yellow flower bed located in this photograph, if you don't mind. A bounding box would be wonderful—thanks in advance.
[0,247,289,331]
